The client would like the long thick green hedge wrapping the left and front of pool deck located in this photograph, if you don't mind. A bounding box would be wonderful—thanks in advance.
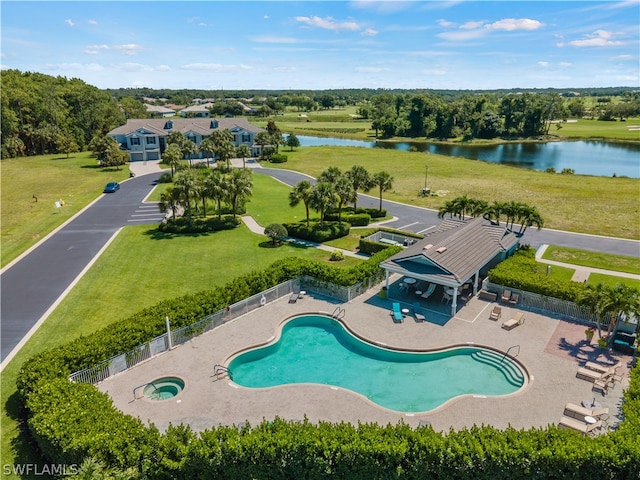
[18,247,640,480]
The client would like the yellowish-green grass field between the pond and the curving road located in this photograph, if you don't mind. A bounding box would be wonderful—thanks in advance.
[262,147,640,239]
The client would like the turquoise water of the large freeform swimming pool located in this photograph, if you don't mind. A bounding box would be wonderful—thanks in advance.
[229,315,527,412]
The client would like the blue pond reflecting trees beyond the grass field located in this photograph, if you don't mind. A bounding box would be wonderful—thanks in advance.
[298,135,640,178]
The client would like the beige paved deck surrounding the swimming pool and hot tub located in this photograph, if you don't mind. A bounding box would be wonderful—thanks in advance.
[98,282,632,432]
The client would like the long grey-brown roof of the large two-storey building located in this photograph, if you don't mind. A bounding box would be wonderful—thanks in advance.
[109,117,264,136]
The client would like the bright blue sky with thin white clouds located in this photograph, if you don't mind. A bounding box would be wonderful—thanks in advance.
[0,0,640,90]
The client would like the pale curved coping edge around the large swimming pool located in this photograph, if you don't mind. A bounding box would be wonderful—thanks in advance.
[222,311,534,417]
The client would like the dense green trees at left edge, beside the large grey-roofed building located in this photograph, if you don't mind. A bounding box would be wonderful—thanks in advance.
[0,70,127,158]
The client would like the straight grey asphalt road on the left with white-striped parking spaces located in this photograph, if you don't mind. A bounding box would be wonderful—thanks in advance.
[0,174,163,361]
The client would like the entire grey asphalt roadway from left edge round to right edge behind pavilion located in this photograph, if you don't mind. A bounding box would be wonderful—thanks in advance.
[0,166,640,367]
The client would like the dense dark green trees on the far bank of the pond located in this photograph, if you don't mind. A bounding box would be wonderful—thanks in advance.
[358,93,640,139]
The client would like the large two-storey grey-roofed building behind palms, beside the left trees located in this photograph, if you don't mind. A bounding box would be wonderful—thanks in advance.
[108,118,264,162]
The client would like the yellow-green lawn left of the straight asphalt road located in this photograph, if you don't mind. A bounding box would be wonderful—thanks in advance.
[0,152,129,267]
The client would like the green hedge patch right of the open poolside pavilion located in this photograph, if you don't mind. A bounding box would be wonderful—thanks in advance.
[489,247,584,302]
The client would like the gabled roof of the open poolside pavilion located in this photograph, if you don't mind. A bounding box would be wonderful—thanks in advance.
[380,217,521,285]
